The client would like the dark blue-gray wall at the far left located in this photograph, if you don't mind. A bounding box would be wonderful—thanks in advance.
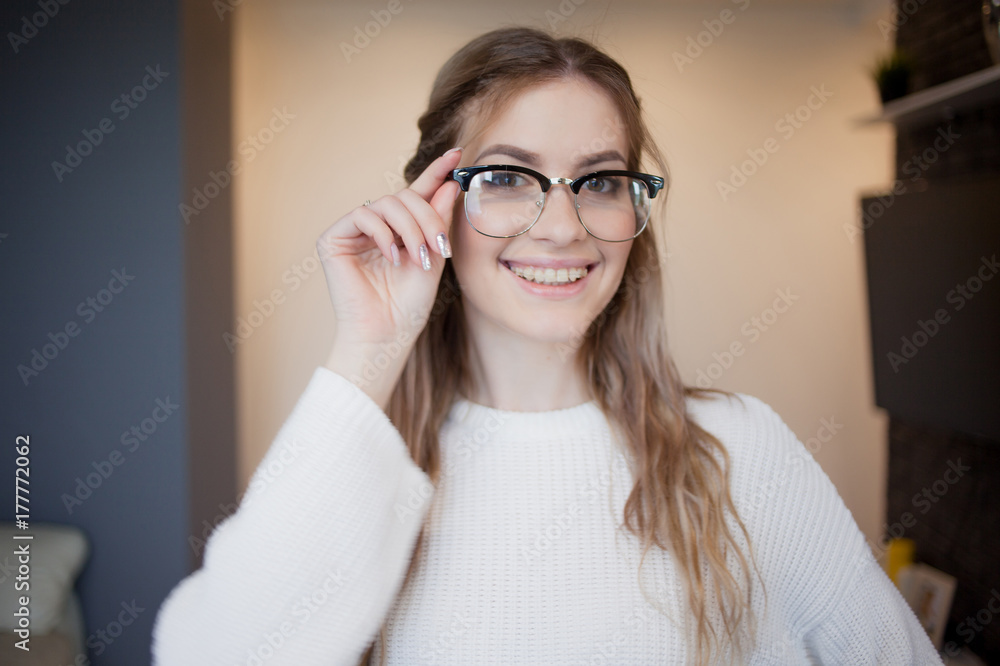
[0,0,199,666]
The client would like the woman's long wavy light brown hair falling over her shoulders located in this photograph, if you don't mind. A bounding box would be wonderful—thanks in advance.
[362,27,756,664]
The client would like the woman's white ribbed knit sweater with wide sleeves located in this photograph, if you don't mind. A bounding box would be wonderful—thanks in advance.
[153,368,941,666]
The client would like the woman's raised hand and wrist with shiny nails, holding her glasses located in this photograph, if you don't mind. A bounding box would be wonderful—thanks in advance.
[317,148,461,408]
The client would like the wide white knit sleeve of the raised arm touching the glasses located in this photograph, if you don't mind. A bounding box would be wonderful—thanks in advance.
[152,367,434,666]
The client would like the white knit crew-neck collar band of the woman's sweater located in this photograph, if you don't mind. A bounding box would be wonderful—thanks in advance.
[448,396,607,439]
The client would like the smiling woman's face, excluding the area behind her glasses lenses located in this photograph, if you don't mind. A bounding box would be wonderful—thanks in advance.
[451,79,633,349]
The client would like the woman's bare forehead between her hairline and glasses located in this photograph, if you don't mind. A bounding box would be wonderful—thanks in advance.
[466,78,628,175]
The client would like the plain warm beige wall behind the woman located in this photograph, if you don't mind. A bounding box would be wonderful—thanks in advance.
[232,0,892,539]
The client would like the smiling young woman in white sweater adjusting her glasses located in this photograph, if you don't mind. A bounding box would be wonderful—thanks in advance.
[154,28,940,666]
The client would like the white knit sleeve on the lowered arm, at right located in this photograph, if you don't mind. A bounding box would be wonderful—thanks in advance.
[712,395,942,666]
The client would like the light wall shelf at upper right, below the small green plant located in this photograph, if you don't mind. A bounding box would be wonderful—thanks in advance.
[856,65,1000,127]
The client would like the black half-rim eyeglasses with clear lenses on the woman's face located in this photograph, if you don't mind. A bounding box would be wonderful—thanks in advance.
[448,164,663,243]
